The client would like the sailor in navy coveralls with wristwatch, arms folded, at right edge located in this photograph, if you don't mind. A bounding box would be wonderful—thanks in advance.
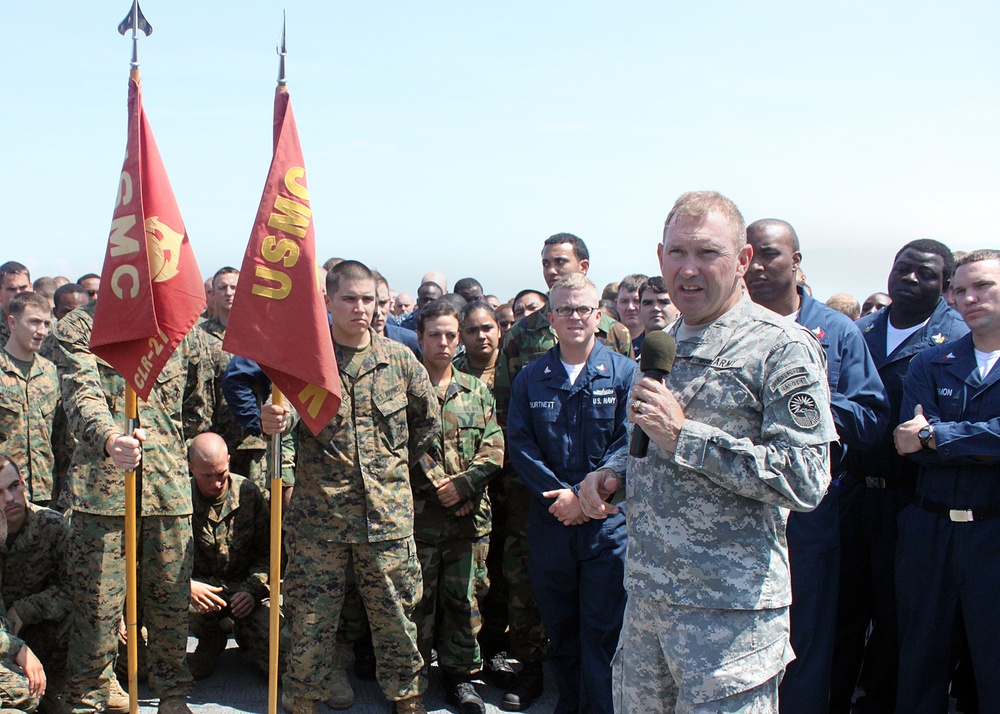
[893,250,1000,714]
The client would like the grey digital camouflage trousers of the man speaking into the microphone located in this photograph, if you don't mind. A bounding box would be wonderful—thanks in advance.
[612,592,795,714]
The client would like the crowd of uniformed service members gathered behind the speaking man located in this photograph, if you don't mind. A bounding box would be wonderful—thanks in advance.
[0,203,1000,714]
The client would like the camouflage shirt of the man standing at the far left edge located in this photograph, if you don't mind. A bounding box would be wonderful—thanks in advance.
[0,349,59,504]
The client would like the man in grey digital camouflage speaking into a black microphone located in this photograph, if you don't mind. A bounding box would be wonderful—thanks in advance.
[579,191,837,714]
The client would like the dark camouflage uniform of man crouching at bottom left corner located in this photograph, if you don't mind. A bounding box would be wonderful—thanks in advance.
[0,503,73,699]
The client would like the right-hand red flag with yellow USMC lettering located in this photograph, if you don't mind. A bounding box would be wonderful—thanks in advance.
[222,87,340,434]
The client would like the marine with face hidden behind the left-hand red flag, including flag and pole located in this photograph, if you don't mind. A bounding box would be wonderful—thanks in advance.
[56,0,210,714]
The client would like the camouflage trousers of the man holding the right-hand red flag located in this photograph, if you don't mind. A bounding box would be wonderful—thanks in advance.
[282,528,426,701]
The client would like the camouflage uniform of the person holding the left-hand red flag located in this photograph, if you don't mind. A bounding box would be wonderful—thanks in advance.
[56,302,209,712]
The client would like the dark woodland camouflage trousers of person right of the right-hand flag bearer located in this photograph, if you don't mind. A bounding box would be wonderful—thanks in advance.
[416,538,490,676]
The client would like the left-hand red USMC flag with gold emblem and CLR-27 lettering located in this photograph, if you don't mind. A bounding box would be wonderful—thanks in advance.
[90,78,205,400]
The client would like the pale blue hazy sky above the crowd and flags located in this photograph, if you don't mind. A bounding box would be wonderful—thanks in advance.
[0,0,1000,299]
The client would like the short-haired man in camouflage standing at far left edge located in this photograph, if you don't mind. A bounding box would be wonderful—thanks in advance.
[0,292,59,506]
